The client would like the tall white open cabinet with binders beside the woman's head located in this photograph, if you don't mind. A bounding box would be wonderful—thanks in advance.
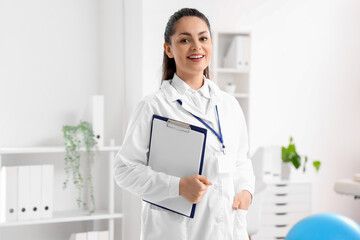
[212,31,251,132]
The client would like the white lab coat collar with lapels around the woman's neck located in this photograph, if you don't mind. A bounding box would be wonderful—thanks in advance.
[160,74,221,121]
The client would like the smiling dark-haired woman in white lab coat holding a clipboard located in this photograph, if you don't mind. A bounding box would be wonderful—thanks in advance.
[115,8,254,240]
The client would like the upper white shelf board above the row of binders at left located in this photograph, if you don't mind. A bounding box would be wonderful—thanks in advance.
[0,146,120,154]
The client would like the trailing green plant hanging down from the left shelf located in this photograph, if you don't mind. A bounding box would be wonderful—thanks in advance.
[62,121,97,214]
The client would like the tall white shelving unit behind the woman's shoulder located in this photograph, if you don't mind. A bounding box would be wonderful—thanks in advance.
[212,31,251,134]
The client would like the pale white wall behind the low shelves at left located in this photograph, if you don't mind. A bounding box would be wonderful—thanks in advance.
[0,0,125,240]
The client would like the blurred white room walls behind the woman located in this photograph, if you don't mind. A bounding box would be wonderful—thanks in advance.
[0,0,360,240]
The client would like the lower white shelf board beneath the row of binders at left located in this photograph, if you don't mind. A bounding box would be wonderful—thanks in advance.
[0,210,124,227]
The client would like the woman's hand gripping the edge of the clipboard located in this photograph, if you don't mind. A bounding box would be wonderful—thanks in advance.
[179,175,212,203]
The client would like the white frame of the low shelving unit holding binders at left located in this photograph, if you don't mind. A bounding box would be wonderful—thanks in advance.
[0,146,124,240]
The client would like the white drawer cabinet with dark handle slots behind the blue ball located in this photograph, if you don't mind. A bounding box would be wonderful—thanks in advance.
[252,180,311,240]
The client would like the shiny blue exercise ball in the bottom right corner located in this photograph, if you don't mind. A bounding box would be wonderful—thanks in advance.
[285,213,360,240]
